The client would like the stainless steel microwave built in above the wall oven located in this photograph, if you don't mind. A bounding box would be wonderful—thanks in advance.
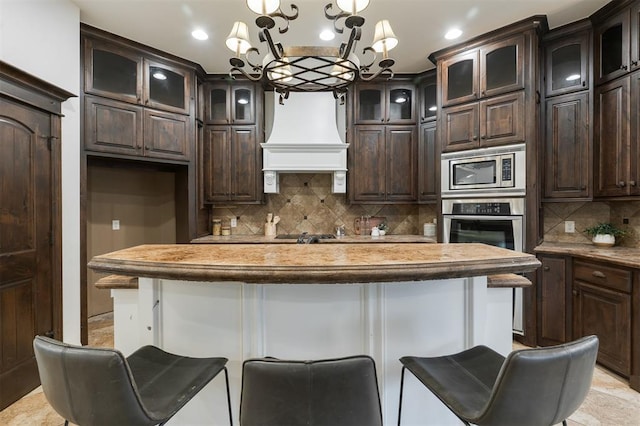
[441,144,526,197]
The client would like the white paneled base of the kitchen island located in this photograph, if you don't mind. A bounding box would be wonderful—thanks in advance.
[112,276,512,426]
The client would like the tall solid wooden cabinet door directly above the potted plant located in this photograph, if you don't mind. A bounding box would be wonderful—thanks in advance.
[593,77,630,197]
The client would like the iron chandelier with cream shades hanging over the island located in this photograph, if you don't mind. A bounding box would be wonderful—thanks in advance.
[226,0,398,103]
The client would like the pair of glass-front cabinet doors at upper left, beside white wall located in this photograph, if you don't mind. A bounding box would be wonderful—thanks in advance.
[84,38,193,114]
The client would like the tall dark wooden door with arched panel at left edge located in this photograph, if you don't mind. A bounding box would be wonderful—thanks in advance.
[0,99,54,410]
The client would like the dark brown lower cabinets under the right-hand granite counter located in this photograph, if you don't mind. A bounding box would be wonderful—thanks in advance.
[536,252,640,392]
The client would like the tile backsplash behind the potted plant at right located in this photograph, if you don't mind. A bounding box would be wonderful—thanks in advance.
[544,201,640,248]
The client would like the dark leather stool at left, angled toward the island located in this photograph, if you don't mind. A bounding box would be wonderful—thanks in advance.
[33,336,232,426]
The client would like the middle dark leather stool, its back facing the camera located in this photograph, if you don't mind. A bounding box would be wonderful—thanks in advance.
[240,355,382,426]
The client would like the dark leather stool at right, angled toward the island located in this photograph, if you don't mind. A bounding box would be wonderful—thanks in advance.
[398,336,598,426]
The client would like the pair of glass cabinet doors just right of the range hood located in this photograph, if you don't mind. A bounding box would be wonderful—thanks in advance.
[354,83,416,124]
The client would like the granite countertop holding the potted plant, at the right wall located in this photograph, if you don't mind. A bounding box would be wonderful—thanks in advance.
[534,242,640,268]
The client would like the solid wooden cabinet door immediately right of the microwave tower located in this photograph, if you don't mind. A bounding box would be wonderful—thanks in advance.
[544,92,591,198]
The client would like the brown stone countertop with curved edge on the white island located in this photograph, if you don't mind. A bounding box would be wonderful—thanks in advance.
[88,243,540,284]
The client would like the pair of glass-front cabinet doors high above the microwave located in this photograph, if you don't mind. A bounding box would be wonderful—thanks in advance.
[440,35,525,106]
